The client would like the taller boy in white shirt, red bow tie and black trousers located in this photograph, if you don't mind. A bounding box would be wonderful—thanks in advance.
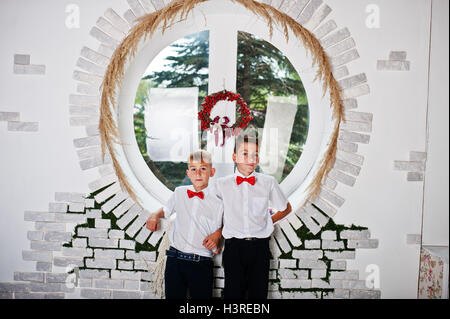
[216,135,292,299]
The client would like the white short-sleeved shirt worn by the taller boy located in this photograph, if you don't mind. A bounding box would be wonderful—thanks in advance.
[215,169,288,239]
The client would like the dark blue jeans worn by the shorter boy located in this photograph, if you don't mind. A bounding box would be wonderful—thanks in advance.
[164,249,214,299]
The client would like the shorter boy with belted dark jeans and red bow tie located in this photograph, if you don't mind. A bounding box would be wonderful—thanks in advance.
[147,150,223,299]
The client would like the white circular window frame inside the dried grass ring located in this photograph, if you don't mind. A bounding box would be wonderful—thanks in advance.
[114,2,334,211]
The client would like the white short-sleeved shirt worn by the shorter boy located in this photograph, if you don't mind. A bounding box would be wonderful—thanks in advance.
[163,183,223,257]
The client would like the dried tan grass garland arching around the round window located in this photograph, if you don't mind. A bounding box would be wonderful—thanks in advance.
[99,0,345,208]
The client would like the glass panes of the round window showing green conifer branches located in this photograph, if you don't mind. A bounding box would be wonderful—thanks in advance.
[133,30,309,190]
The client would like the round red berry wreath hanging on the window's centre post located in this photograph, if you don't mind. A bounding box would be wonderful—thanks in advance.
[198,90,253,131]
